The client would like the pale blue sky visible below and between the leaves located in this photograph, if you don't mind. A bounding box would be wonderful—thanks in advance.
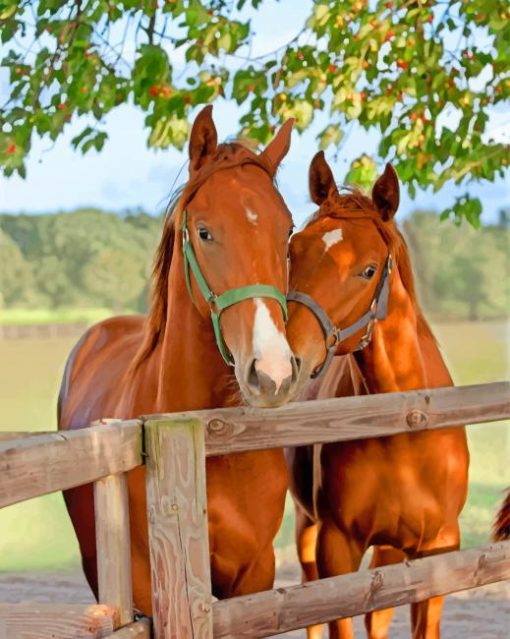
[0,0,510,224]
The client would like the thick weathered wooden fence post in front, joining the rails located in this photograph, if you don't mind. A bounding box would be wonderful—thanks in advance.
[145,418,213,639]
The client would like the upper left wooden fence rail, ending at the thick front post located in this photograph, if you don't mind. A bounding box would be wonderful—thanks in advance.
[0,420,142,508]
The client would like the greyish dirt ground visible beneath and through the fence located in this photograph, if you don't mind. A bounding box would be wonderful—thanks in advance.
[0,565,510,639]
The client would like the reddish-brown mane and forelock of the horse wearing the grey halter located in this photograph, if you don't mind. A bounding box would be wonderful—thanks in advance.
[310,186,435,341]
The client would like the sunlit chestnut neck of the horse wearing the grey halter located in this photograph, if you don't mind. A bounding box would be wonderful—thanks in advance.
[356,269,452,393]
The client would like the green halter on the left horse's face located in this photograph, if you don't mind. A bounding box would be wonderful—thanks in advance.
[181,210,287,366]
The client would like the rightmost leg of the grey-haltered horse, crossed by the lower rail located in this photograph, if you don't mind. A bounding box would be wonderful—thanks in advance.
[411,523,460,639]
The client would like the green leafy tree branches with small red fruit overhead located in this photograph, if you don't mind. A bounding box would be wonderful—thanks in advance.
[0,0,510,226]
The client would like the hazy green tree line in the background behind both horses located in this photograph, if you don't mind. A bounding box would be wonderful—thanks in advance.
[0,209,510,320]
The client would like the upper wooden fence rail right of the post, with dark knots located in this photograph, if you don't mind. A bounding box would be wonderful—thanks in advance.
[182,382,510,456]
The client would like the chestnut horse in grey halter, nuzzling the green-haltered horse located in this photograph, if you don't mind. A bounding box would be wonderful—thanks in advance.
[287,153,469,639]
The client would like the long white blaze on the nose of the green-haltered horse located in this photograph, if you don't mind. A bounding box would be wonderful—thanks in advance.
[253,298,292,395]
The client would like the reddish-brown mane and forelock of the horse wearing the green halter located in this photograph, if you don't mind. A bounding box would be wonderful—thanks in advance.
[128,139,271,374]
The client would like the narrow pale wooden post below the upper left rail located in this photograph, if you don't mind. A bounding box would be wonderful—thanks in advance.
[94,473,133,625]
